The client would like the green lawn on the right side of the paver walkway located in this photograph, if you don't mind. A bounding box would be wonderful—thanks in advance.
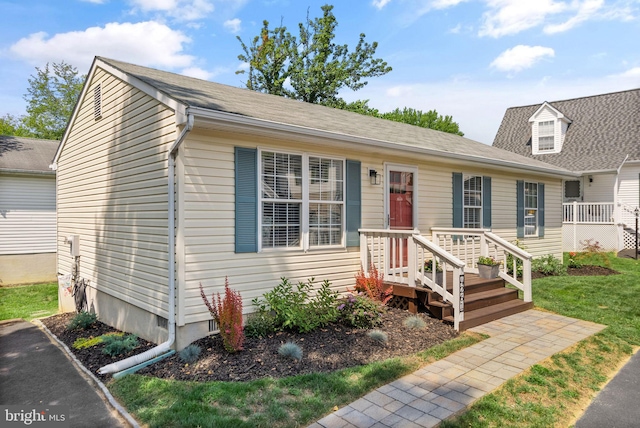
[441,254,640,428]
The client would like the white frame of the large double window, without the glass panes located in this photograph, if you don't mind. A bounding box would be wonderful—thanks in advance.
[258,148,347,252]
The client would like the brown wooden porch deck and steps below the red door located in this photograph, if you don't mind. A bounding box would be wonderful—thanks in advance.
[388,272,533,331]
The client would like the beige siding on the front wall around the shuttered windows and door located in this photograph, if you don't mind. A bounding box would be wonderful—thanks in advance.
[176,131,562,325]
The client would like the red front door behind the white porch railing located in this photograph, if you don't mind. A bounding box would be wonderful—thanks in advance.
[388,171,414,267]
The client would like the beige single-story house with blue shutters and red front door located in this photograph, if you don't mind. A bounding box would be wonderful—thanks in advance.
[54,57,572,349]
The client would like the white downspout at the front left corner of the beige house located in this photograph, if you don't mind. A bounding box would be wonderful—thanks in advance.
[98,114,193,374]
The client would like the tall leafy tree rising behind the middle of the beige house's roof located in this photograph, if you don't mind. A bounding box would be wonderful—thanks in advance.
[237,5,391,105]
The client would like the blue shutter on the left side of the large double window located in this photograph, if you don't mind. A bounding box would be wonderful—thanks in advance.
[235,147,258,253]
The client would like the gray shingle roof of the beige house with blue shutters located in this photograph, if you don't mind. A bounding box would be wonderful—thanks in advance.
[96,57,568,173]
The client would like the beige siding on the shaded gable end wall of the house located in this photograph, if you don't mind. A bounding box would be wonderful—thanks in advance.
[57,66,176,317]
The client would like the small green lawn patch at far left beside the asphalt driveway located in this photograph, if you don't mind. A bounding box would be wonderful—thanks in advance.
[0,282,58,321]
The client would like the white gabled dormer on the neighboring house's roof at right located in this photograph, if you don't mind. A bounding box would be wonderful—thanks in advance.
[529,102,571,155]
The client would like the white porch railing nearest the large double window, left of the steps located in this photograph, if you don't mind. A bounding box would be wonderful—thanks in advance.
[359,229,465,330]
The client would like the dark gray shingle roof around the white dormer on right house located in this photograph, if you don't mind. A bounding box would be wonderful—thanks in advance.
[493,89,640,172]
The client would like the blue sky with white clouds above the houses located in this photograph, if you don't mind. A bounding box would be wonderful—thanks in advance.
[0,0,640,144]
